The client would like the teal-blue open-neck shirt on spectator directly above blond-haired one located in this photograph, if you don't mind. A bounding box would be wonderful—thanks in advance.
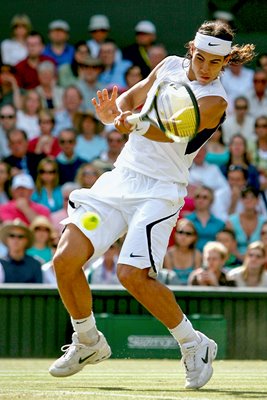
[186,212,225,252]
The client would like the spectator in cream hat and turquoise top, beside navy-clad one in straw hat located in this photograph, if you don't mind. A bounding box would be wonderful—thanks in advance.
[26,215,53,264]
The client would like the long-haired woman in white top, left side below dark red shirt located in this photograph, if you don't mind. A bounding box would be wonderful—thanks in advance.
[17,90,42,140]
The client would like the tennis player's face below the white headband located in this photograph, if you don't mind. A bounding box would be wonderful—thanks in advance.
[189,48,228,85]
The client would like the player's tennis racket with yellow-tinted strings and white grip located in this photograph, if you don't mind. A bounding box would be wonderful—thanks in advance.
[127,81,200,143]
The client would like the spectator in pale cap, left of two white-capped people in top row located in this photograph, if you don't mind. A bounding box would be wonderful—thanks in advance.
[87,15,122,61]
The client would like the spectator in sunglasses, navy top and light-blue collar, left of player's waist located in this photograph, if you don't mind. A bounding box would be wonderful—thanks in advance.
[56,129,86,185]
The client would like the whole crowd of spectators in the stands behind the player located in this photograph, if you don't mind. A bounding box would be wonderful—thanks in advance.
[0,14,267,287]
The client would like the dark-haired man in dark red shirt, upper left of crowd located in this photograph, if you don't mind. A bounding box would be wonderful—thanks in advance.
[16,31,54,90]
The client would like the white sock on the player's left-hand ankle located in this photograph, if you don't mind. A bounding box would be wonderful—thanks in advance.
[71,313,99,346]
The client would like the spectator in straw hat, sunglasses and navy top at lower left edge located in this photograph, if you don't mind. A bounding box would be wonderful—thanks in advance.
[0,219,42,283]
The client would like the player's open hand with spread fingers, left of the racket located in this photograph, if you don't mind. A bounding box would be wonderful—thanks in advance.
[92,86,120,124]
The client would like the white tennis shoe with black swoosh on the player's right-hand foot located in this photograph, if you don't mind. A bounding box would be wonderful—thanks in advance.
[180,332,217,389]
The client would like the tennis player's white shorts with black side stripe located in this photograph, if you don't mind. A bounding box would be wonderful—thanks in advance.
[62,168,186,276]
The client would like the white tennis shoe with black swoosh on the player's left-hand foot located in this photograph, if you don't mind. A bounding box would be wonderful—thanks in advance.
[49,332,111,377]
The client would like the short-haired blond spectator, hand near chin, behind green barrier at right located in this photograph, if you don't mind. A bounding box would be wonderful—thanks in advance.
[188,242,235,286]
